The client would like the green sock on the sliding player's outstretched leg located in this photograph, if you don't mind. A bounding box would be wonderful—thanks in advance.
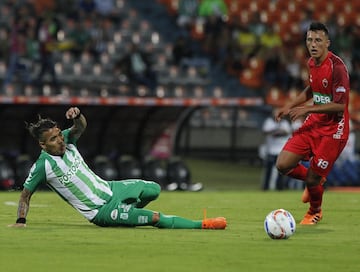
[155,213,202,229]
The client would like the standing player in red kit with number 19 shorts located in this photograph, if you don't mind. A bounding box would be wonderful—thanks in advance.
[275,22,350,225]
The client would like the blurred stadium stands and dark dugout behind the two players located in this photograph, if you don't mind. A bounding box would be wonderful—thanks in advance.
[0,0,360,189]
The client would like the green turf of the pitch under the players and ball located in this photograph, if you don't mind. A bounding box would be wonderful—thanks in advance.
[0,190,360,272]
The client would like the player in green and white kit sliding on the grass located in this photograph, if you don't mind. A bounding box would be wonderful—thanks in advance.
[10,107,226,229]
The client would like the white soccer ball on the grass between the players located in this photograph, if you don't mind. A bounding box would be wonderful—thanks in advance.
[264,209,296,239]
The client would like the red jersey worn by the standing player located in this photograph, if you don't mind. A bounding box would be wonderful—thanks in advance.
[301,52,350,140]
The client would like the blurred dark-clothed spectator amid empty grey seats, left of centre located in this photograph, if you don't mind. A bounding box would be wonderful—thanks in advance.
[114,43,157,91]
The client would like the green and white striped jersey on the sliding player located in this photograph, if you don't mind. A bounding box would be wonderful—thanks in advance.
[24,129,113,221]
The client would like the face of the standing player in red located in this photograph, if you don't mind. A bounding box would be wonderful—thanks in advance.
[306,30,330,63]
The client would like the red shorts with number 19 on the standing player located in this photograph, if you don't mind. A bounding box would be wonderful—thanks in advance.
[283,132,347,177]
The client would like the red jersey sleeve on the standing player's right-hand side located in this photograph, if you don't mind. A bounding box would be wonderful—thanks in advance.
[332,63,350,104]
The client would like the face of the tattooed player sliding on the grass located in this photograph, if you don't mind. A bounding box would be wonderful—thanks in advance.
[40,127,66,156]
